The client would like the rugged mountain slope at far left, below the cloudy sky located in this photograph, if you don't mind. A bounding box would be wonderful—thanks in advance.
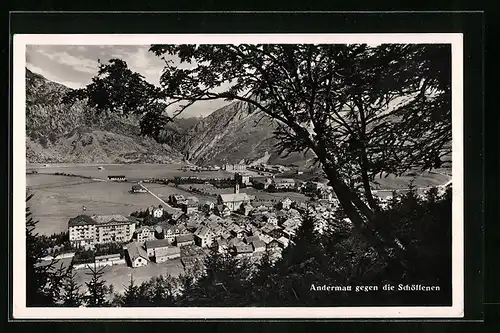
[26,69,183,163]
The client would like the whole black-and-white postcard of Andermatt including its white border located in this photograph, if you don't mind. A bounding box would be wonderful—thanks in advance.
[12,34,464,319]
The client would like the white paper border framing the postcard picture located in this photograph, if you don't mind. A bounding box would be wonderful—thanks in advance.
[12,34,464,319]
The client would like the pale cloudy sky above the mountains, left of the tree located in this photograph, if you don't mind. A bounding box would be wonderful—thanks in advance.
[26,45,227,117]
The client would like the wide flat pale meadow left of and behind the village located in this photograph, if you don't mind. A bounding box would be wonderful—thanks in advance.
[26,164,231,235]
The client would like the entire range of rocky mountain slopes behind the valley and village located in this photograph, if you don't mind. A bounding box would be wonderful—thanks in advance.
[26,69,314,167]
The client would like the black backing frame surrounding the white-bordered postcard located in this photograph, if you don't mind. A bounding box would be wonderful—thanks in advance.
[6,12,485,322]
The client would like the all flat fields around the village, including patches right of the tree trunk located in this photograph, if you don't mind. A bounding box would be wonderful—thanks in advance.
[26,164,449,235]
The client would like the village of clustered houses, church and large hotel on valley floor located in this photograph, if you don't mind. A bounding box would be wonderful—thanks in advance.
[38,165,450,284]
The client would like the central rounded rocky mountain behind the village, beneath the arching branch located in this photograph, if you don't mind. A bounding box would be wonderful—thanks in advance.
[178,101,314,166]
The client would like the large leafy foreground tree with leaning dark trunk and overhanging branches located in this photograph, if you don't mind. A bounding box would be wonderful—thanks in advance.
[64,44,451,269]
